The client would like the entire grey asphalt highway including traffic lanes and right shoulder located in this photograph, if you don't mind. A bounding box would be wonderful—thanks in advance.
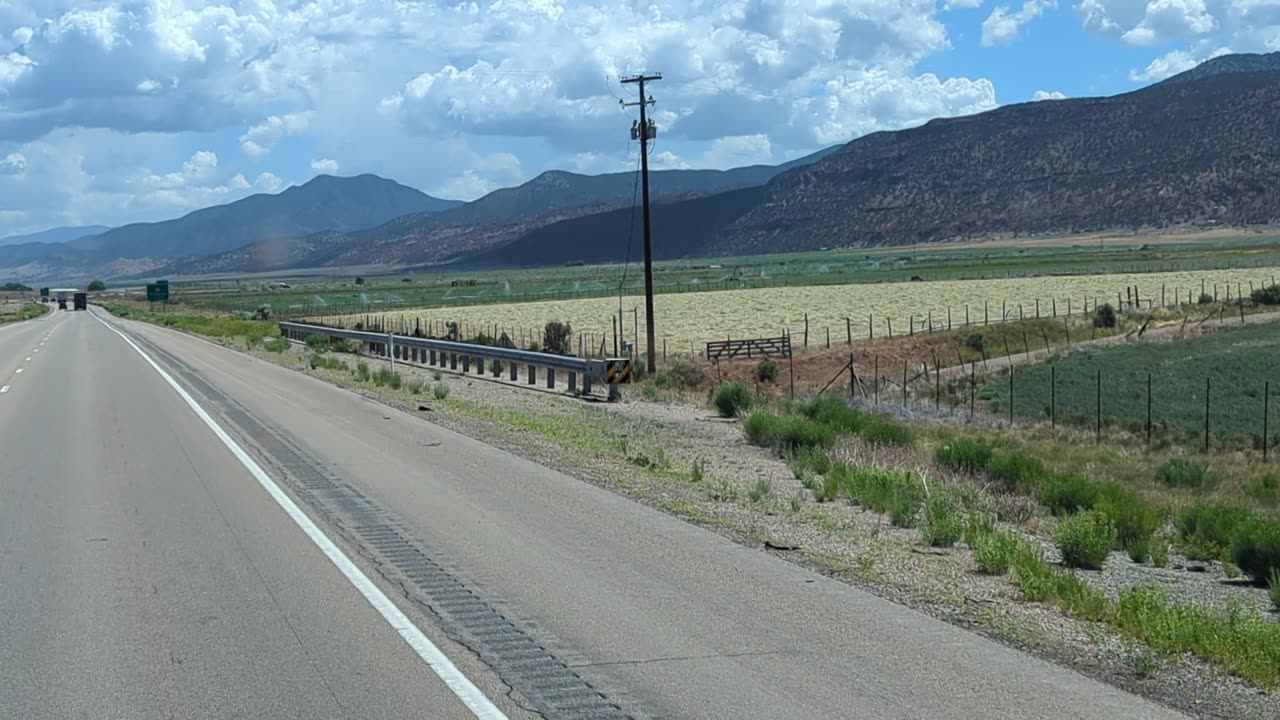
[0,311,1180,720]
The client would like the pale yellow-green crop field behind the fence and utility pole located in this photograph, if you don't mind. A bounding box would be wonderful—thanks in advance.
[332,268,1280,352]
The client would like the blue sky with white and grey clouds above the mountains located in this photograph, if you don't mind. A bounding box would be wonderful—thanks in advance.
[0,0,1280,237]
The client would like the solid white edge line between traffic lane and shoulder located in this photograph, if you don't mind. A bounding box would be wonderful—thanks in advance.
[93,315,507,720]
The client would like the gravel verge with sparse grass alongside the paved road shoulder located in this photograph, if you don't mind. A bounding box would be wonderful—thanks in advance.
[225,335,1277,719]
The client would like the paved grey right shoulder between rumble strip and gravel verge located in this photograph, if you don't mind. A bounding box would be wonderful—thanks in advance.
[104,308,1180,719]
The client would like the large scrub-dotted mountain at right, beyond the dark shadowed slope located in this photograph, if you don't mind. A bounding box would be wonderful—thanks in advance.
[716,56,1280,254]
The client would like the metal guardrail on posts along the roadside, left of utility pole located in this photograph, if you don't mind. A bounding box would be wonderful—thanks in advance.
[279,322,630,398]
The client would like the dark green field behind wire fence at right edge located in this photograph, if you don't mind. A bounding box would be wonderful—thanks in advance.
[984,323,1280,447]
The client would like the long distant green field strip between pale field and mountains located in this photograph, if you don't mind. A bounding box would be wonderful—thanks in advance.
[172,233,1280,316]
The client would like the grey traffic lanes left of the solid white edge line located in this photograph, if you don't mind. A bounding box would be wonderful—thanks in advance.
[0,313,521,720]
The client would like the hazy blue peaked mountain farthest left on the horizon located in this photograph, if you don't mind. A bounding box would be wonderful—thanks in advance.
[0,174,461,279]
